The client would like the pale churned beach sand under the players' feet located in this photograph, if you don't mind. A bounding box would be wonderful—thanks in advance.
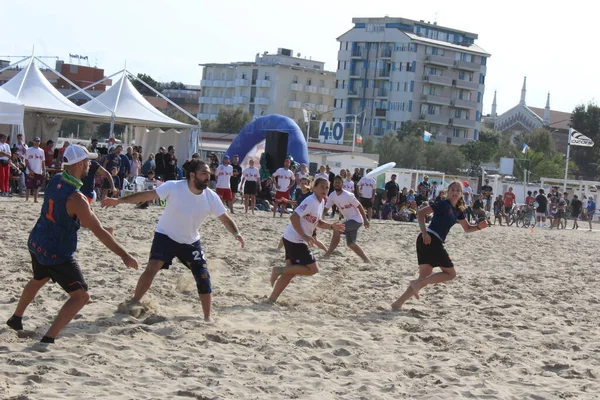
[0,198,600,400]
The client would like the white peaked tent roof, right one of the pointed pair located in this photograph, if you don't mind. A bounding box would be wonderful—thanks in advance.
[81,76,192,128]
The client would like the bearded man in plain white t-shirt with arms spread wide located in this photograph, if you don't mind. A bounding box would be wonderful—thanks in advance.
[102,159,244,322]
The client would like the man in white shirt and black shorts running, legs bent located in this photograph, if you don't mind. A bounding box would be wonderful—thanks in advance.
[269,178,344,302]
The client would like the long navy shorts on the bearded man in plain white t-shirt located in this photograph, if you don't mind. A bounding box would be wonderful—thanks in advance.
[150,232,212,294]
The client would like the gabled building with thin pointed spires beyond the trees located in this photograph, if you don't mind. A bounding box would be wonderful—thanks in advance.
[484,77,571,153]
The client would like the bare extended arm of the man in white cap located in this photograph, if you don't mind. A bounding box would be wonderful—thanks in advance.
[67,193,138,269]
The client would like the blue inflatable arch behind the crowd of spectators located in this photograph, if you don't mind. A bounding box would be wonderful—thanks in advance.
[225,114,308,165]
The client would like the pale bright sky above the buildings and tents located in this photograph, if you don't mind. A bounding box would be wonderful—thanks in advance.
[0,0,600,114]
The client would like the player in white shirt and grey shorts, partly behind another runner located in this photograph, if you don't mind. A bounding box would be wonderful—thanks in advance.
[324,175,371,263]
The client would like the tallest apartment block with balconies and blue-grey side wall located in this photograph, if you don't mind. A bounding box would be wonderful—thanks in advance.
[333,17,490,145]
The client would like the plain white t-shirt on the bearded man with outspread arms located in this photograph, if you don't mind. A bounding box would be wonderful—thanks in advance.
[156,180,226,244]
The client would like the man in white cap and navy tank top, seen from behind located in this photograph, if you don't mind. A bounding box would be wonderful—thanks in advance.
[6,145,138,343]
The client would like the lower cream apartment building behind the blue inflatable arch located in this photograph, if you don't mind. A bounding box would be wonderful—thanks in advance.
[198,48,335,120]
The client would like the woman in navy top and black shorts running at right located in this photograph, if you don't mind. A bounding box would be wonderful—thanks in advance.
[392,181,488,310]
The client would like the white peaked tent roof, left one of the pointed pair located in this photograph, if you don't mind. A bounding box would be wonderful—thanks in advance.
[2,59,98,117]
